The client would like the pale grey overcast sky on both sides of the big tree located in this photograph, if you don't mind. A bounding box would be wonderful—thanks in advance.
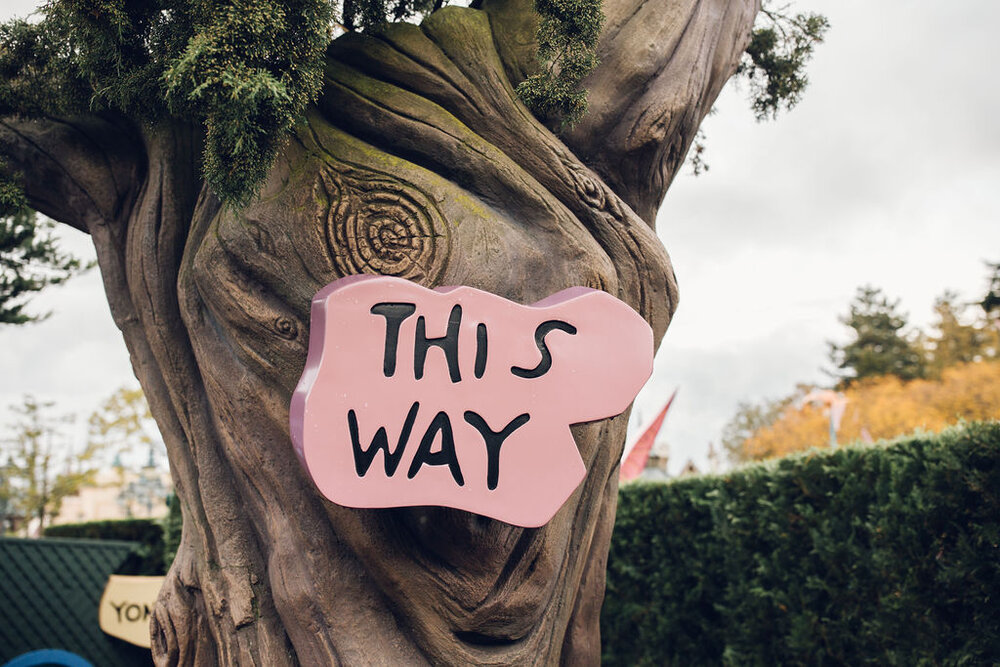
[0,0,1000,471]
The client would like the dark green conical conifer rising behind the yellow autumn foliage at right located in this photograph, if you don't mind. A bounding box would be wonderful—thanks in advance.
[830,285,925,387]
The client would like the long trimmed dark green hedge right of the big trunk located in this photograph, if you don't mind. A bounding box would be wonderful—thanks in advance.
[601,422,1000,665]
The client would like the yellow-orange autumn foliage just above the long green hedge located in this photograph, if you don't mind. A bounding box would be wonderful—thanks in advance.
[743,360,1000,459]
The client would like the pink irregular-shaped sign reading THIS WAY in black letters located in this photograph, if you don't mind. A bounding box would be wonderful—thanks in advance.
[291,276,653,527]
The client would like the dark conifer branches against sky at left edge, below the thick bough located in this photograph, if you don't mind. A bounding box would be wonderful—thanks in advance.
[0,207,90,324]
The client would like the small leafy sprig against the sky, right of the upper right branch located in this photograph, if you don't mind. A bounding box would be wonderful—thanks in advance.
[736,2,830,120]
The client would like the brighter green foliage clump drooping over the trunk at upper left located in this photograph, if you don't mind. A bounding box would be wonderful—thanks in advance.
[163,0,332,204]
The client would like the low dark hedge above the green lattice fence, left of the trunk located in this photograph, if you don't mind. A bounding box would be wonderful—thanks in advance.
[44,519,167,576]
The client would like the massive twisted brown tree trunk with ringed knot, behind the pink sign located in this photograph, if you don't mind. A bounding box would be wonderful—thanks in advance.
[0,0,757,666]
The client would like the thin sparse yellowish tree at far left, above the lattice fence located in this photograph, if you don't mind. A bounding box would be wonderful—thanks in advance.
[0,396,100,534]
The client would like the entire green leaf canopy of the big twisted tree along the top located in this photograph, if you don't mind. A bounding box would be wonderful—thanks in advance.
[0,0,827,205]
